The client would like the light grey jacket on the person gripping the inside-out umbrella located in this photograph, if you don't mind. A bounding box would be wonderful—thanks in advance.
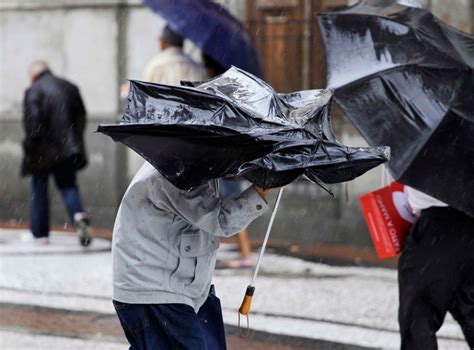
[112,163,268,311]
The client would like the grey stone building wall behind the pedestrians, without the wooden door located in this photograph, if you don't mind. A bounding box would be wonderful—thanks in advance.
[0,0,472,245]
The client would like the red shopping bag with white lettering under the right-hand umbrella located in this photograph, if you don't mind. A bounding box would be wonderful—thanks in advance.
[359,182,415,259]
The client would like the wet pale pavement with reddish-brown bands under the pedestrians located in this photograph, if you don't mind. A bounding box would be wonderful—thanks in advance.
[0,229,468,350]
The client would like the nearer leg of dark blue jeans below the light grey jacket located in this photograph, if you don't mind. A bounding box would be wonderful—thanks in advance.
[114,300,207,350]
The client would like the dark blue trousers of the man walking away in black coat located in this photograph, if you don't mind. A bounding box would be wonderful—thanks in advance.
[31,161,83,238]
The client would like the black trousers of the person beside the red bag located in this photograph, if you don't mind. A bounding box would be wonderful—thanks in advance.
[398,207,474,350]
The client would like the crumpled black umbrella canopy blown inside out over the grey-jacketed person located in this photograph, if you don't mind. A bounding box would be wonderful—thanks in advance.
[97,67,388,190]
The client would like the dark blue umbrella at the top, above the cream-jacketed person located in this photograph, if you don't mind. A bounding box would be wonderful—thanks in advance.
[143,0,262,77]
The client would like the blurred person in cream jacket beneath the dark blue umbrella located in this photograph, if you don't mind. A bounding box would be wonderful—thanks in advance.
[143,26,206,85]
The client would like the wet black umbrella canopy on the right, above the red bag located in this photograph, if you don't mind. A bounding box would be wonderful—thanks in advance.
[318,0,474,216]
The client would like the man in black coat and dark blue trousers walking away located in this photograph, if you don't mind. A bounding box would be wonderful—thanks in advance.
[21,60,92,246]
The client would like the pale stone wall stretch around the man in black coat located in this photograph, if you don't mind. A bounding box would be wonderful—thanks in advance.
[0,0,164,228]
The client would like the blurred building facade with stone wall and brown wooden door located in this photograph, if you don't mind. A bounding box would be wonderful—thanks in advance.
[0,0,474,263]
